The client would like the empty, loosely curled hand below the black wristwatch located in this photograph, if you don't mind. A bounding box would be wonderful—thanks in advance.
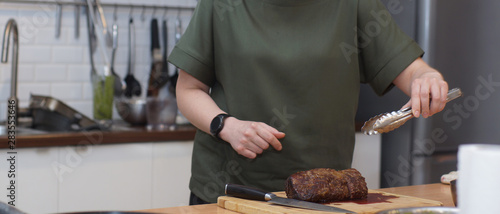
[219,117,285,159]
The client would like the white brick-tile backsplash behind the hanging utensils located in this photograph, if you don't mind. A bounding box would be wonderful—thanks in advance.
[0,0,197,121]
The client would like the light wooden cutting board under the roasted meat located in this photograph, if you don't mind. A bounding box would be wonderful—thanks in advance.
[217,190,443,214]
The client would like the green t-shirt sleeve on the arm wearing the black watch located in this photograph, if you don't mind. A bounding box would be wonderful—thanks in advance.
[168,0,215,86]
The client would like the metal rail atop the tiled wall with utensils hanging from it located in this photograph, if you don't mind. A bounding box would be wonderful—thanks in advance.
[0,0,194,10]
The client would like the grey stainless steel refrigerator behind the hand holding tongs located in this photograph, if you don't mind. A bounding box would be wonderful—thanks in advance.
[356,0,500,187]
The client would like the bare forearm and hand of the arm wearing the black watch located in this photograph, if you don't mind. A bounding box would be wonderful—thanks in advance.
[176,70,285,159]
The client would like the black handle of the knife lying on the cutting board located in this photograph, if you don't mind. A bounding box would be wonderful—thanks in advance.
[226,184,276,201]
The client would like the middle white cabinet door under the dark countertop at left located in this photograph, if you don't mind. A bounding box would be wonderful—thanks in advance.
[59,143,153,212]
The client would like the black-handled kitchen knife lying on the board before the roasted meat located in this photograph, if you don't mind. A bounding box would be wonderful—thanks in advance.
[225,184,355,213]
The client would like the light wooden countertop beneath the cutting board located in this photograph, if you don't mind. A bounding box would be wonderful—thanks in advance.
[142,183,454,214]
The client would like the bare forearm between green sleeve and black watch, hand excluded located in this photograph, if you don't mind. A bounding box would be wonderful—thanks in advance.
[176,71,223,133]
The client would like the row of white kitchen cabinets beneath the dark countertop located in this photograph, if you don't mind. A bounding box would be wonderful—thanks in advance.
[0,141,193,213]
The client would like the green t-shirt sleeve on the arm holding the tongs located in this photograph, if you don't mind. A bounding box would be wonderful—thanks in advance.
[357,0,424,95]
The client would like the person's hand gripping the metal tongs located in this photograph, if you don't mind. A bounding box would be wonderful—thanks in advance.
[403,68,448,118]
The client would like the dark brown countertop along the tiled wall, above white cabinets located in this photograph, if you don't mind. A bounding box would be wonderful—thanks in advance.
[0,124,196,149]
